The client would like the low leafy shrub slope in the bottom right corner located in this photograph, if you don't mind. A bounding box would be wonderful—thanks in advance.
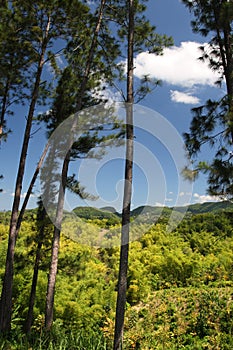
[125,288,233,350]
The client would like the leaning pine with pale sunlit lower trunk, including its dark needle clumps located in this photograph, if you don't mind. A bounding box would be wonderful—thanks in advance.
[42,0,124,330]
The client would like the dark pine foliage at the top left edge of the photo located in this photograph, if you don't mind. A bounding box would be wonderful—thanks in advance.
[0,2,31,141]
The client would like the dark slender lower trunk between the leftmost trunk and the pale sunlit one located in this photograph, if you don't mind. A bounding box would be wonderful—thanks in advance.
[25,208,46,333]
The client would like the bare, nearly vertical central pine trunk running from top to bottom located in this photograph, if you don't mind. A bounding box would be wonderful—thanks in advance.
[113,0,134,350]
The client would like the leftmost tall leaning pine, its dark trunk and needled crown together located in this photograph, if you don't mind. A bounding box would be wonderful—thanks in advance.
[0,1,90,332]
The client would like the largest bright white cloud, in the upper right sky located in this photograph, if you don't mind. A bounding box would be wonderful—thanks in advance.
[135,41,218,88]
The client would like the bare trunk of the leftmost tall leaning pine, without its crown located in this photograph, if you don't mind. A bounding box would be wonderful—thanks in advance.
[0,19,50,332]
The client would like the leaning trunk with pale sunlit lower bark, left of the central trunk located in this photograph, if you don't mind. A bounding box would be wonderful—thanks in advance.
[45,0,106,331]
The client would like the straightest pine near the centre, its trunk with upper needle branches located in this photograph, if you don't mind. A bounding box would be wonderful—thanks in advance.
[110,0,172,350]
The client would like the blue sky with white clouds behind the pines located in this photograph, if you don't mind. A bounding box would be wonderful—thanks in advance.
[0,0,224,210]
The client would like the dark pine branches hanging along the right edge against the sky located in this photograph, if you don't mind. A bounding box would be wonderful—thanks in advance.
[183,0,233,199]
